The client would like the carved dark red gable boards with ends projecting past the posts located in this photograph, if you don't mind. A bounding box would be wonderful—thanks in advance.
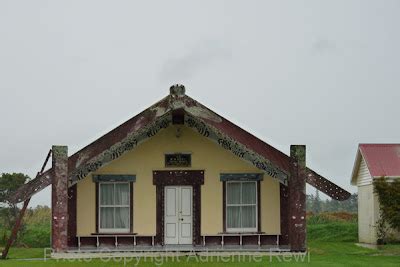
[11,86,350,202]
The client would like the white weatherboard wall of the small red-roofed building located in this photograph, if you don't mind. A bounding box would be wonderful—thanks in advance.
[357,156,379,244]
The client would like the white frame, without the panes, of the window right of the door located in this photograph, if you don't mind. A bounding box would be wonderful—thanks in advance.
[225,181,259,233]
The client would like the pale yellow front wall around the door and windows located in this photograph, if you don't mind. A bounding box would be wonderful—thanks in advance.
[77,125,280,235]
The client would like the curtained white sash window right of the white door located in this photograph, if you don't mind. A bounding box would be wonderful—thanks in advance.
[226,181,258,232]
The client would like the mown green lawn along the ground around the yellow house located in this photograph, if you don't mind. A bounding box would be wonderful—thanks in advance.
[0,241,400,267]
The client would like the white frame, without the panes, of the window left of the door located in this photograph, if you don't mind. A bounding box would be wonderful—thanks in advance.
[98,182,132,233]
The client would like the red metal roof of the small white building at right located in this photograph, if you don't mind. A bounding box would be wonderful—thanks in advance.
[359,144,400,177]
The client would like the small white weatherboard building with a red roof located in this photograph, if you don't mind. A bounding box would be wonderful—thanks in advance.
[351,144,400,244]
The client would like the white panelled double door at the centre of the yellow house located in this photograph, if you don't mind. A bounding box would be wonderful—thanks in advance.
[164,186,193,244]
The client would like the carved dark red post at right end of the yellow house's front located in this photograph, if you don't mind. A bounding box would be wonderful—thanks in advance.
[288,145,306,251]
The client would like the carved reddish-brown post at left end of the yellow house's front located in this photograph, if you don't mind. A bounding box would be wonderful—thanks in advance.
[51,146,68,252]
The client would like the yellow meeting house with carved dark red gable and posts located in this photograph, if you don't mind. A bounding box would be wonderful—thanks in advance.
[11,85,350,255]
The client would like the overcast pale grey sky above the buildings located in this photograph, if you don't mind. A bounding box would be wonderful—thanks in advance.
[0,0,400,205]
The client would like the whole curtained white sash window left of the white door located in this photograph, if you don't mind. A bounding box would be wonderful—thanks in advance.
[99,182,131,233]
